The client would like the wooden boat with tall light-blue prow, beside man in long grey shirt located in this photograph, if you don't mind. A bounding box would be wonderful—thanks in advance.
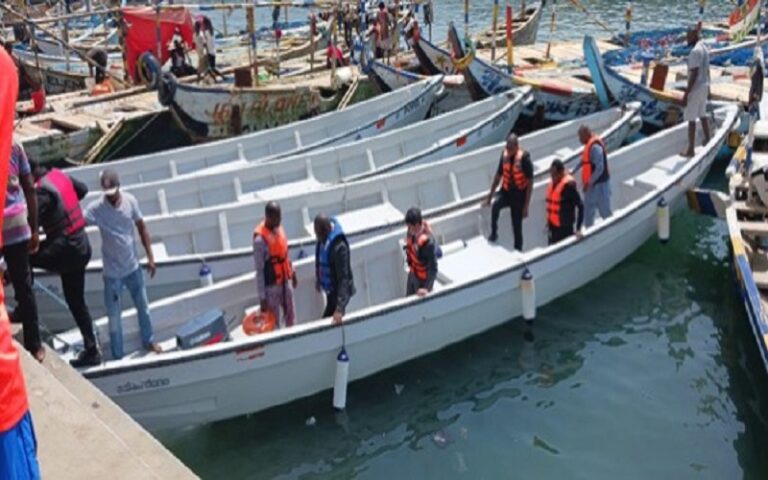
[584,35,683,127]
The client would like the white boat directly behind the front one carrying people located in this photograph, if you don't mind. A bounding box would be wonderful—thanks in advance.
[33,105,640,329]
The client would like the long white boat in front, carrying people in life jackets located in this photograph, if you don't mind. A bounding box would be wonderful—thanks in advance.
[57,103,737,430]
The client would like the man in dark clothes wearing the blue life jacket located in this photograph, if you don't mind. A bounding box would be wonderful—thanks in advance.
[315,213,355,324]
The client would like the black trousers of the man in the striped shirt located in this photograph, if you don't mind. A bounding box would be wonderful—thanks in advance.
[3,242,42,355]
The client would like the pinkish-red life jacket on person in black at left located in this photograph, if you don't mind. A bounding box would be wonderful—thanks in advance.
[39,168,85,236]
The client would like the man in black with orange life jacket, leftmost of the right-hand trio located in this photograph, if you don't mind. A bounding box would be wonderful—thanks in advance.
[483,133,533,251]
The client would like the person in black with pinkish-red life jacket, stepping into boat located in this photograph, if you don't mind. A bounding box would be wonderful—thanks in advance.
[30,161,101,367]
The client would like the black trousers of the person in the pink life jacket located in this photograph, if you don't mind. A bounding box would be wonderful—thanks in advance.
[30,236,97,351]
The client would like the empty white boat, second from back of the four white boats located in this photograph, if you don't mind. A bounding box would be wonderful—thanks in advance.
[81,89,530,215]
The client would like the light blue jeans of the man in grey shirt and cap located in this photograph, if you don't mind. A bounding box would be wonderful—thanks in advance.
[104,267,153,360]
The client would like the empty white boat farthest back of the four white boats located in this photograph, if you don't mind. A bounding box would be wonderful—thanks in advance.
[68,77,442,190]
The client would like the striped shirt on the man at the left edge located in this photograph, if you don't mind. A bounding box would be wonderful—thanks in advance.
[3,142,32,245]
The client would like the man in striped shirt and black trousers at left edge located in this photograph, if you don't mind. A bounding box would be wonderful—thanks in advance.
[3,142,45,362]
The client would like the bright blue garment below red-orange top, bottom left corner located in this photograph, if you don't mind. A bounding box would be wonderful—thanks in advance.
[0,411,40,480]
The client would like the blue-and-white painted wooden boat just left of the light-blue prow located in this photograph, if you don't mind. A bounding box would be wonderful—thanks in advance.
[448,24,601,122]
